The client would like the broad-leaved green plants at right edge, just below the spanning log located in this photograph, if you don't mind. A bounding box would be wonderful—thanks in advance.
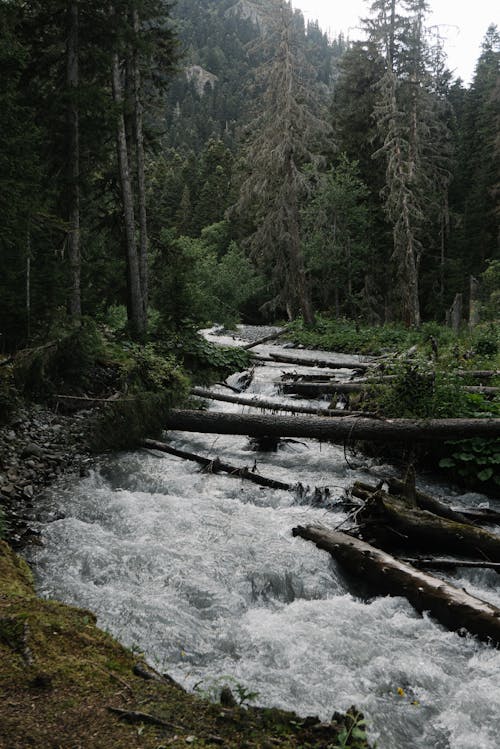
[439,437,500,490]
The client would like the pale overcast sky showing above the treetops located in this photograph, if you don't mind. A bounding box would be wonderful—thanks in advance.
[292,0,500,83]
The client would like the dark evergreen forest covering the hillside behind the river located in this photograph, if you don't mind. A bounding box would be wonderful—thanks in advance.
[0,0,500,352]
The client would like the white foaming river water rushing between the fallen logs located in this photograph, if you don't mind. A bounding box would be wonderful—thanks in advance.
[33,331,500,749]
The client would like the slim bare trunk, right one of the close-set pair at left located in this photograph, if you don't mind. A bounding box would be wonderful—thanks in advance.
[132,10,149,315]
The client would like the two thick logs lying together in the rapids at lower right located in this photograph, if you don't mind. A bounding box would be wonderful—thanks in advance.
[293,480,500,646]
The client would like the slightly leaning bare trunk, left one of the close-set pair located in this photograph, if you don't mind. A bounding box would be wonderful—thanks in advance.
[111,6,146,338]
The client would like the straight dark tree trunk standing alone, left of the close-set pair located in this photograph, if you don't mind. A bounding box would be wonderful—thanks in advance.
[66,0,82,322]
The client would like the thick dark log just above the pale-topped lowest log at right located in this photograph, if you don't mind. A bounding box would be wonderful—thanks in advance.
[358,491,500,562]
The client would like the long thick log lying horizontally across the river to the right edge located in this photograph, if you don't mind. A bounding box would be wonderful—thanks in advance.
[165,409,500,443]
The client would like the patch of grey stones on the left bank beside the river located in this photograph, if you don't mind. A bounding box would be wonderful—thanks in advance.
[0,404,93,548]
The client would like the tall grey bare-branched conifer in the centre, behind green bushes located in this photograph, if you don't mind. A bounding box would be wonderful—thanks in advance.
[233,3,326,324]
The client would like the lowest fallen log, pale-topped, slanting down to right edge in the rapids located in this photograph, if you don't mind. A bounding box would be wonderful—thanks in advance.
[292,526,500,645]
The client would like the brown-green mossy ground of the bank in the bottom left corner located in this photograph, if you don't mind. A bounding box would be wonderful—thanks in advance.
[0,542,368,749]
